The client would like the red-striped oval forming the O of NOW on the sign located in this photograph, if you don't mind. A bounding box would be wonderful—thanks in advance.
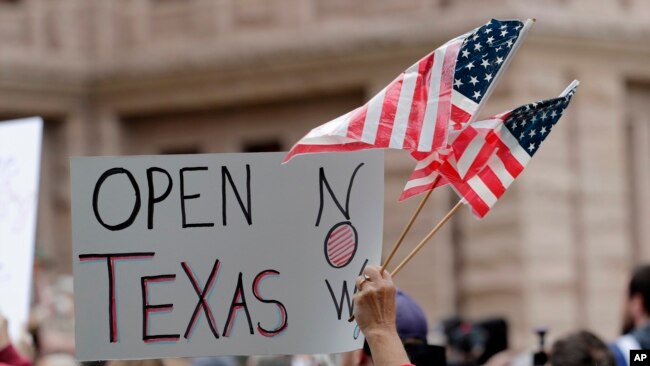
[325,221,357,268]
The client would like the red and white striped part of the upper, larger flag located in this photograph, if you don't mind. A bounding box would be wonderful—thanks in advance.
[284,35,467,162]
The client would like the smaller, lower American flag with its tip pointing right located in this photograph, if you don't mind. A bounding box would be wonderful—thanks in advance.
[439,81,578,218]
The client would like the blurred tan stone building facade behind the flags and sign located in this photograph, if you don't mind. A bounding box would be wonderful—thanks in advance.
[0,0,650,349]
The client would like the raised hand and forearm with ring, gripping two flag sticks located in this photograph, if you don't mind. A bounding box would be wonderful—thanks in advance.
[354,266,411,366]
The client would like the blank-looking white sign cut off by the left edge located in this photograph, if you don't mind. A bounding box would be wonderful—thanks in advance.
[0,118,43,340]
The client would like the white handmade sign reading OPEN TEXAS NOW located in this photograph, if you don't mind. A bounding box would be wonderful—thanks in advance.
[71,151,383,360]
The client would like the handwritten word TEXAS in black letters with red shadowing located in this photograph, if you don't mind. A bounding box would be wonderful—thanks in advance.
[79,252,288,343]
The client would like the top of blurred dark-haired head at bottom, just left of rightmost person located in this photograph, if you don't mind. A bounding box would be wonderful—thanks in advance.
[551,330,615,366]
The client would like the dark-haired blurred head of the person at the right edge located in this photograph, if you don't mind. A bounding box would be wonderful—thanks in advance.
[623,265,650,333]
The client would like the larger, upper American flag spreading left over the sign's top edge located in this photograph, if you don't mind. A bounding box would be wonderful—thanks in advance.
[285,20,528,162]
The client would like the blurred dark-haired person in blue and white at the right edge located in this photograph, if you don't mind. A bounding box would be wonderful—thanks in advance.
[610,265,650,366]
